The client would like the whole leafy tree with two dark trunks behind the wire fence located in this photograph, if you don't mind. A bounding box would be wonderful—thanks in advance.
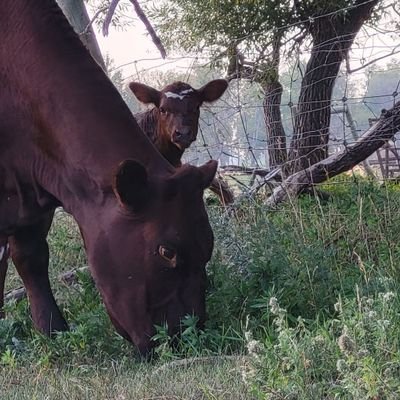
[146,0,385,171]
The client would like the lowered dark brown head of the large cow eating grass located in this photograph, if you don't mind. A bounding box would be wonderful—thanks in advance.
[87,160,217,353]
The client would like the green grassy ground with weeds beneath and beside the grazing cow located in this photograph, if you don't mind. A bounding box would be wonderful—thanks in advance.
[0,178,400,400]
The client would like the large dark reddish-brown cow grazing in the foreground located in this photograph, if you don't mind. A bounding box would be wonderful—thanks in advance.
[0,0,217,353]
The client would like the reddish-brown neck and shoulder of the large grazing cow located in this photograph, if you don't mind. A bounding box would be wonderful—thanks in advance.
[0,0,169,223]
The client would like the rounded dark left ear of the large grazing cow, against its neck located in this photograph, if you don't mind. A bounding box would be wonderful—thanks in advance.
[113,160,149,212]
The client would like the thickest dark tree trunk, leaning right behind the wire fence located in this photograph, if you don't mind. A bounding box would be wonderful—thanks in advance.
[285,0,378,175]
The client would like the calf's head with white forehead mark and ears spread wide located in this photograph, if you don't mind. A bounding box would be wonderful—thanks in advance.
[129,79,228,151]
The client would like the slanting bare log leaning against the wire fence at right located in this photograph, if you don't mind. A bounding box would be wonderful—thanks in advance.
[266,102,400,206]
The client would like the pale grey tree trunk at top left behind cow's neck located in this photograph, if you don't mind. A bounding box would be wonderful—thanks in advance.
[57,0,106,70]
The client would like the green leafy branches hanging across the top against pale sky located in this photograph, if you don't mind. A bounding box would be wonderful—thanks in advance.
[145,0,383,73]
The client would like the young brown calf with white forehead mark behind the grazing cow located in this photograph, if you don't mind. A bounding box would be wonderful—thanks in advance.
[129,79,233,204]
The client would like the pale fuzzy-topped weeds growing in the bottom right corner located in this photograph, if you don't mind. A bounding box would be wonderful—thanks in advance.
[244,290,400,400]
